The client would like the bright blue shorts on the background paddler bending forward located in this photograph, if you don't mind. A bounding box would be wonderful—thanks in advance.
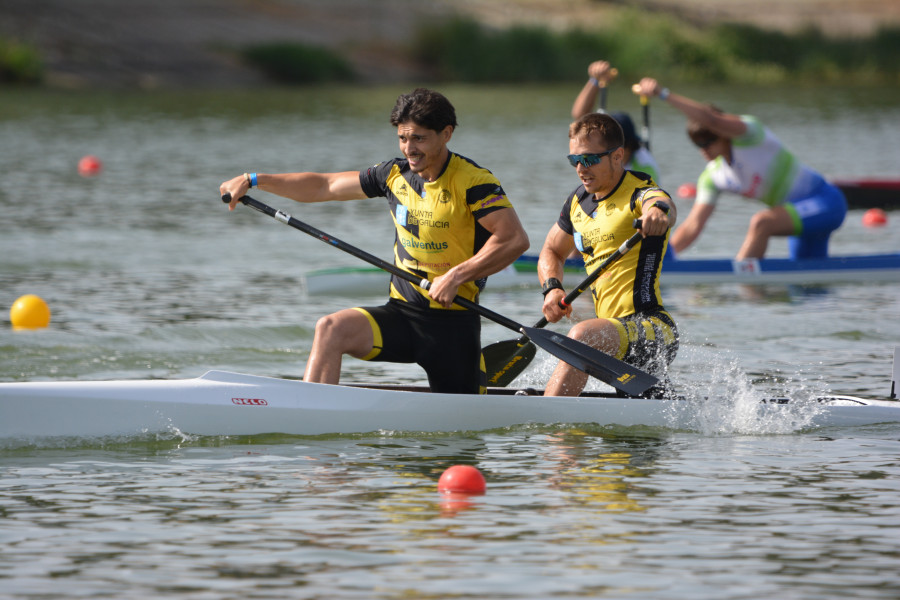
[784,179,847,260]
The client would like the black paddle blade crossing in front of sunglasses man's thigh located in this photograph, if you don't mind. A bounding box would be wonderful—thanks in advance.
[522,327,659,396]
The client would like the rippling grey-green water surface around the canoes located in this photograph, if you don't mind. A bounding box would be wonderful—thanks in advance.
[0,86,900,600]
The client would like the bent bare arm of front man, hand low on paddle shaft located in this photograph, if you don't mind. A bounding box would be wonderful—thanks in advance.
[428,208,529,308]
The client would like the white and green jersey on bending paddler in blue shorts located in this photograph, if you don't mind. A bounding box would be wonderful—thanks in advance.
[696,115,822,206]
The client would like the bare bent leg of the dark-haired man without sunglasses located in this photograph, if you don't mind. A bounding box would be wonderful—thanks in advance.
[303,308,374,384]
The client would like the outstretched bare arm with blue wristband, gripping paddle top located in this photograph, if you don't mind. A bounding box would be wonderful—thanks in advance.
[219,171,366,210]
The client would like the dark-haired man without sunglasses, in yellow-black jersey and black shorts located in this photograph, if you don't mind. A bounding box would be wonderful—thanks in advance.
[219,88,528,393]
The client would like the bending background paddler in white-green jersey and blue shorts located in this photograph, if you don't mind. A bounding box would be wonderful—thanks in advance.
[638,77,847,260]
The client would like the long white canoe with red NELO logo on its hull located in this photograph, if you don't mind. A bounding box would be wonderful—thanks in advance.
[0,371,900,439]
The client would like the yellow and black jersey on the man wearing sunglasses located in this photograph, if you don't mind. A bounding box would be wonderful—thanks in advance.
[557,171,669,318]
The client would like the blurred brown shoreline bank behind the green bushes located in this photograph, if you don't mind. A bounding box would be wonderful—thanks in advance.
[0,0,900,89]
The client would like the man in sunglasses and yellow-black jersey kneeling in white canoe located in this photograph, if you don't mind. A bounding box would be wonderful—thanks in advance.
[538,113,678,396]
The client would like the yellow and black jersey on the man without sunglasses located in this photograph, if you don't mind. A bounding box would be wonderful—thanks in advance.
[359,152,512,310]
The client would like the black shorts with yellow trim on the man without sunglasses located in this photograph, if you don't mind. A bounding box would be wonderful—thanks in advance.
[356,299,487,394]
